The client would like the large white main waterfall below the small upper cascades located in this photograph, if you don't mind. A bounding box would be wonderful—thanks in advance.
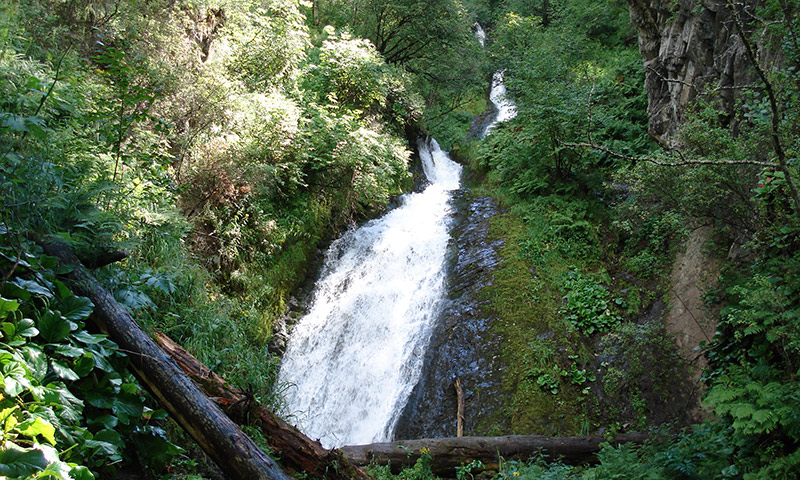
[278,140,461,448]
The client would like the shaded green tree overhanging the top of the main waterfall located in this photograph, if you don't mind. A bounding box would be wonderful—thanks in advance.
[315,0,490,149]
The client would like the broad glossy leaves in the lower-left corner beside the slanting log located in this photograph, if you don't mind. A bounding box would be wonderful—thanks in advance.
[0,238,182,479]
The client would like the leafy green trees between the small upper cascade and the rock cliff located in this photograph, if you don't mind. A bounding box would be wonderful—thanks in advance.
[479,2,649,198]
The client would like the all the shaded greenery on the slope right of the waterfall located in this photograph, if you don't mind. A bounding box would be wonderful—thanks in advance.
[450,1,800,478]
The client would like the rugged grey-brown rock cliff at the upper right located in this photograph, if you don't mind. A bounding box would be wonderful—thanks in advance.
[628,0,755,148]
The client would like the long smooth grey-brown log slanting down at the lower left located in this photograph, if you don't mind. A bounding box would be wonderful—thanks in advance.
[43,243,289,480]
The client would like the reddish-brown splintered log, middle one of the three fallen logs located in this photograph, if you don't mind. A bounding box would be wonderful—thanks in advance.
[154,332,372,480]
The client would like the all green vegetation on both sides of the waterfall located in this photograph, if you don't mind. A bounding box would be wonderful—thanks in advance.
[0,0,800,479]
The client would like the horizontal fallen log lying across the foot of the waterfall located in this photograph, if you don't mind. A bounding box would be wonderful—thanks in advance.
[341,433,648,475]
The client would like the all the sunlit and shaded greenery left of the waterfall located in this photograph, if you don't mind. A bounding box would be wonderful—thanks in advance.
[0,0,479,478]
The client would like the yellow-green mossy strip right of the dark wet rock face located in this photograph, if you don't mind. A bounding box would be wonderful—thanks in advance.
[478,213,586,435]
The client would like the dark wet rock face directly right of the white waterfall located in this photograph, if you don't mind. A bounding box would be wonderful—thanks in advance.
[394,190,502,440]
